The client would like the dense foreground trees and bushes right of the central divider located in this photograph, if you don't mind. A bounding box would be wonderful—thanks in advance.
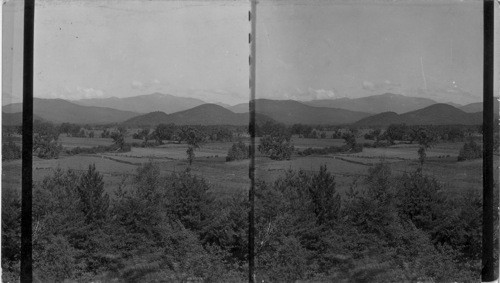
[255,163,482,282]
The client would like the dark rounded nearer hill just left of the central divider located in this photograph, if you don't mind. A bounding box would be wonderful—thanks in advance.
[123,104,269,126]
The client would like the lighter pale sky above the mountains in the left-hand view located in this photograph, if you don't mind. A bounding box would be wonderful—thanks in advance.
[3,0,250,104]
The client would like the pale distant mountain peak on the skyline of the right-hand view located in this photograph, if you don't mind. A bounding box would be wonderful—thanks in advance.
[303,93,437,114]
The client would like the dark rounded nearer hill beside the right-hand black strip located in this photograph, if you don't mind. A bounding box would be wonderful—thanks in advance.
[354,103,483,126]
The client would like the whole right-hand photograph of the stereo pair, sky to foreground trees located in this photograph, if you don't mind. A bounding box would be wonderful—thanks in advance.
[252,0,498,282]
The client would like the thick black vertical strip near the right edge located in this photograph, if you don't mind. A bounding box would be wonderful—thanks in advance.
[481,0,496,282]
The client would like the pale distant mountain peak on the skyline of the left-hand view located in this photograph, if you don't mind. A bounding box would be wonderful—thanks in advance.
[72,92,206,114]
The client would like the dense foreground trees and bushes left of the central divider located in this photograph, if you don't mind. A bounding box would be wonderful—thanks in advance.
[2,163,247,282]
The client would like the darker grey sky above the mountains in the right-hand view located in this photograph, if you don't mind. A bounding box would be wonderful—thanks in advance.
[257,0,483,104]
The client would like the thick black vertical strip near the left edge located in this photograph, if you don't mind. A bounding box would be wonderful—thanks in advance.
[20,0,35,282]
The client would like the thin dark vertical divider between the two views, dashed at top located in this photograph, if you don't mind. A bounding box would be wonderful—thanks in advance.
[248,0,257,283]
